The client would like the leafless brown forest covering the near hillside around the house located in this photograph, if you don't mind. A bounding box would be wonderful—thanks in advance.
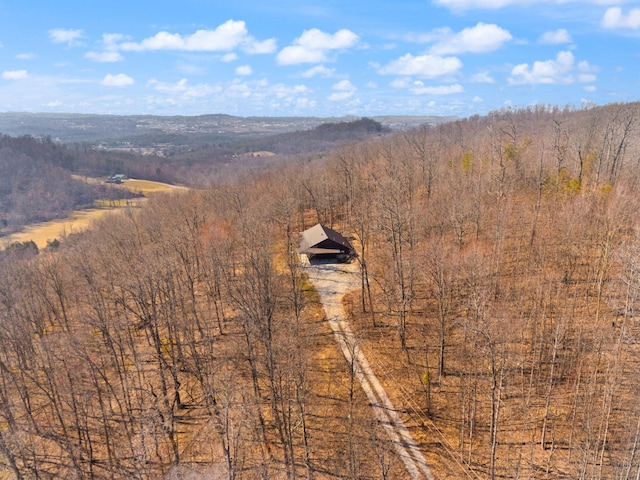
[0,104,640,480]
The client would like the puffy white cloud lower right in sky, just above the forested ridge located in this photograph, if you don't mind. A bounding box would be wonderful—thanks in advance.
[509,51,596,85]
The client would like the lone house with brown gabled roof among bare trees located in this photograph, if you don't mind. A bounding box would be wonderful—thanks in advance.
[298,223,357,262]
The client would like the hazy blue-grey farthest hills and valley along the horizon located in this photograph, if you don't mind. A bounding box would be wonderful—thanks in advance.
[0,112,455,146]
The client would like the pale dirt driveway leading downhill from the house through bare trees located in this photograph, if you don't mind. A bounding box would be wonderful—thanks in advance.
[304,257,435,480]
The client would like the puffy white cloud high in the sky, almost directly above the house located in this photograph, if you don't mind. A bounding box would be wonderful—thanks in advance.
[277,28,360,65]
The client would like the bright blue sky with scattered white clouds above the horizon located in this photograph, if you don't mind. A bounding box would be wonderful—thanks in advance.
[0,0,640,116]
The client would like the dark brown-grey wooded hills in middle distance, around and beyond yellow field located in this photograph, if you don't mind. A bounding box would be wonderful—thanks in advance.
[0,117,390,236]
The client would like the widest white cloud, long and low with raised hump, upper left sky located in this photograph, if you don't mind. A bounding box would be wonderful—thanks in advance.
[119,20,276,54]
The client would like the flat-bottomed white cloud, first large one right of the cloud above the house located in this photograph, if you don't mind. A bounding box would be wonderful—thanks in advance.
[430,22,513,55]
